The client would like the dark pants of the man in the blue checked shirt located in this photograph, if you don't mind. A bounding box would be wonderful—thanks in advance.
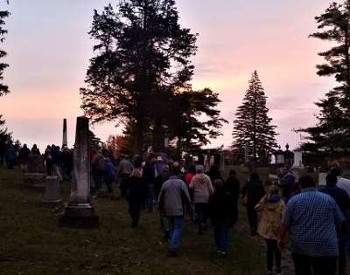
[293,253,337,275]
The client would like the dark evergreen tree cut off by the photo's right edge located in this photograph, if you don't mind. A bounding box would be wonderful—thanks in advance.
[298,0,350,163]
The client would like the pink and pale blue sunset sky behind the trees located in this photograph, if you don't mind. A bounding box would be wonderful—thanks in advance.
[0,0,335,153]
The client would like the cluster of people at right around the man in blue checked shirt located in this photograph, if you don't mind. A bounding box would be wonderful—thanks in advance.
[242,169,350,275]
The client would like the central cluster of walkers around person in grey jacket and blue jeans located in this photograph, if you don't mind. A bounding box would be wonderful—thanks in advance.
[117,155,240,257]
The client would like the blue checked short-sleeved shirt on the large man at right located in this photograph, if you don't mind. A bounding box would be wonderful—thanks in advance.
[282,188,344,257]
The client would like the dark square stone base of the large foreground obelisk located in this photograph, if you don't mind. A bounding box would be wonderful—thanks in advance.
[58,203,98,228]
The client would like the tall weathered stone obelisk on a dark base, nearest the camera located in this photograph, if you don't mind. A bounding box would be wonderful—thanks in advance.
[59,116,98,227]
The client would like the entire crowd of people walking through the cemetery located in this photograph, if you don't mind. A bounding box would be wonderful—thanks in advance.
[5,144,350,275]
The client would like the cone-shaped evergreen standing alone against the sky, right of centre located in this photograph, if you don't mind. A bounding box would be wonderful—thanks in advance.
[232,71,277,165]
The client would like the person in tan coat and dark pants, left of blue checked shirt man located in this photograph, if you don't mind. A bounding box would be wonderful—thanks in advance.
[255,185,285,275]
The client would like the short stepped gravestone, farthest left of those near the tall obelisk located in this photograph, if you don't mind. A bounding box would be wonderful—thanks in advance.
[22,155,46,188]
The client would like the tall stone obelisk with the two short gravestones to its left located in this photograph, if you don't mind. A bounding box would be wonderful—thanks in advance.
[22,116,98,227]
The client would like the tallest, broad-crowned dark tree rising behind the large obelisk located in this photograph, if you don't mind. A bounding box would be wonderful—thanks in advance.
[80,0,196,155]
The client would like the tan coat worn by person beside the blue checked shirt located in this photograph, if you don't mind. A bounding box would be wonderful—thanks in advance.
[255,196,285,240]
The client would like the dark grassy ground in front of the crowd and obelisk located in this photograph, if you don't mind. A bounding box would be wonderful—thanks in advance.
[0,168,265,275]
